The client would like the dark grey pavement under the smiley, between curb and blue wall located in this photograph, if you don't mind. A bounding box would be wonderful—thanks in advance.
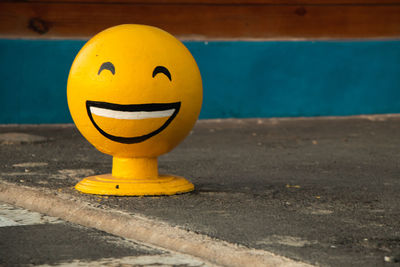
[0,115,400,266]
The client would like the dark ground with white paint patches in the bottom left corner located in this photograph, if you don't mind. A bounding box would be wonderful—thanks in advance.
[0,202,211,267]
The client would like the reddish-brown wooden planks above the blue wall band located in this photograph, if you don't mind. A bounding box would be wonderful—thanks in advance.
[0,0,400,40]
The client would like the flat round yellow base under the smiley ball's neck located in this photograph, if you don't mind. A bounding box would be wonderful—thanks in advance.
[75,174,194,196]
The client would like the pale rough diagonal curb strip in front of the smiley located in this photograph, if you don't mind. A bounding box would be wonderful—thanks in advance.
[0,181,311,267]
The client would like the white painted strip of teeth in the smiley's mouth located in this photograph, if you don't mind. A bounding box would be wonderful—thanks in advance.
[90,107,175,120]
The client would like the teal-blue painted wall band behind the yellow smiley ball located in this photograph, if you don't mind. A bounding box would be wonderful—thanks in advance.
[0,39,400,123]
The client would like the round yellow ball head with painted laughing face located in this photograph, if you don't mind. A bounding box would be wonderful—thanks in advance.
[67,25,202,157]
